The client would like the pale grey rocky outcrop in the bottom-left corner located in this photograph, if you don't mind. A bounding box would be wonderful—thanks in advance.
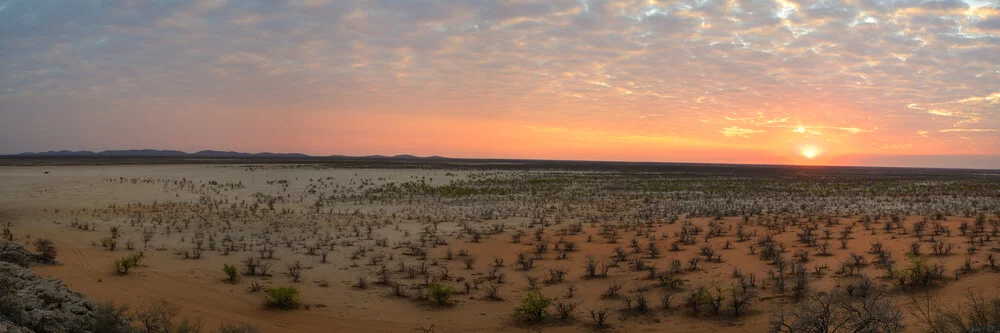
[0,241,94,333]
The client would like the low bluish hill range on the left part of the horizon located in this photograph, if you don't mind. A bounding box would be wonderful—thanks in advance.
[13,149,445,159]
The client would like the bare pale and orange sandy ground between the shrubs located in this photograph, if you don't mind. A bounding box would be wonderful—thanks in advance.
[0,165,1000,332]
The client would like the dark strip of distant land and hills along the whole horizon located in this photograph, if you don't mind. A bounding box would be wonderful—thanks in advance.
[0,149,1000,170]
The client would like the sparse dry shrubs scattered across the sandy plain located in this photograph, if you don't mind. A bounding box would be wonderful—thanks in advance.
[2,165,1000,333]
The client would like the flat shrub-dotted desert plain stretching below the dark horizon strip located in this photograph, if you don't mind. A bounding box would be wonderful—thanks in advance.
[0,159,1000,332]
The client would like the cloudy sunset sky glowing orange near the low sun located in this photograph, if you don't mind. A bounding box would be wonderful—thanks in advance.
[0,0,1000,168]
